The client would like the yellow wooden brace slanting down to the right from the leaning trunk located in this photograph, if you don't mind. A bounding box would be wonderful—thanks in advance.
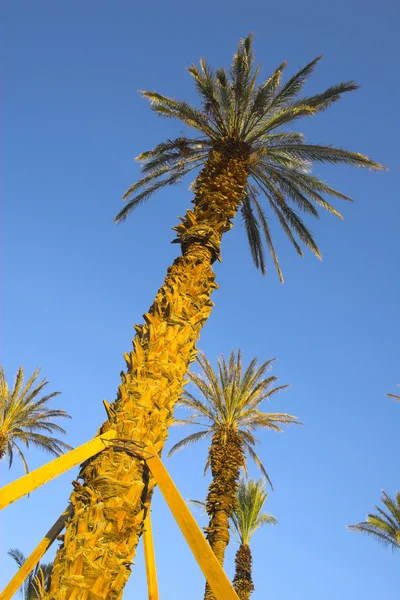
[145,443,239,600]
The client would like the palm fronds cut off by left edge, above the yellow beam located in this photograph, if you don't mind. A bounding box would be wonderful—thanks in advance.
[0,366,71,473]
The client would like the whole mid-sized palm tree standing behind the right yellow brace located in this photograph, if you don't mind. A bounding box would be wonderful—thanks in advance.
[169,350,298,600]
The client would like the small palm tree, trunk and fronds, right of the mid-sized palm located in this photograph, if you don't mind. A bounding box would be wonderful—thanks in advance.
[231,479,277,600]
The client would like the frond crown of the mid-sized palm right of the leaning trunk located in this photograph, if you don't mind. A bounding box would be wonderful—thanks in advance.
[168,350,299,483]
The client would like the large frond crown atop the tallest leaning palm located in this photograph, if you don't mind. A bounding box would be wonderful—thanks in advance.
[115,34,384,281]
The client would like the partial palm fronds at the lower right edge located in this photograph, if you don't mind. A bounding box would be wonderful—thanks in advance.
[349,490,400,550]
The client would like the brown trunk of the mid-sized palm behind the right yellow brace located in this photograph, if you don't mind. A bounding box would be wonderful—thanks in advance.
[204,429,245,600]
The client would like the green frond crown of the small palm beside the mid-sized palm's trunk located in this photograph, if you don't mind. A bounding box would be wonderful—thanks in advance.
[231,478,278,546]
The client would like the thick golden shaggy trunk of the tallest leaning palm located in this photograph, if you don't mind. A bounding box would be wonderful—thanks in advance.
[48,146,247,600]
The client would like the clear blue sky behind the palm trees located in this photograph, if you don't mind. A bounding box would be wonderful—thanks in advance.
[0,0,400,600]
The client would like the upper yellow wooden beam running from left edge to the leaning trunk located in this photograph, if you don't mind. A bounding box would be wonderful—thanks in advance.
[0,430,116,510]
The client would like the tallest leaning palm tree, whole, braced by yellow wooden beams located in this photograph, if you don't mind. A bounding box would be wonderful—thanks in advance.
[51,36,383,600]
